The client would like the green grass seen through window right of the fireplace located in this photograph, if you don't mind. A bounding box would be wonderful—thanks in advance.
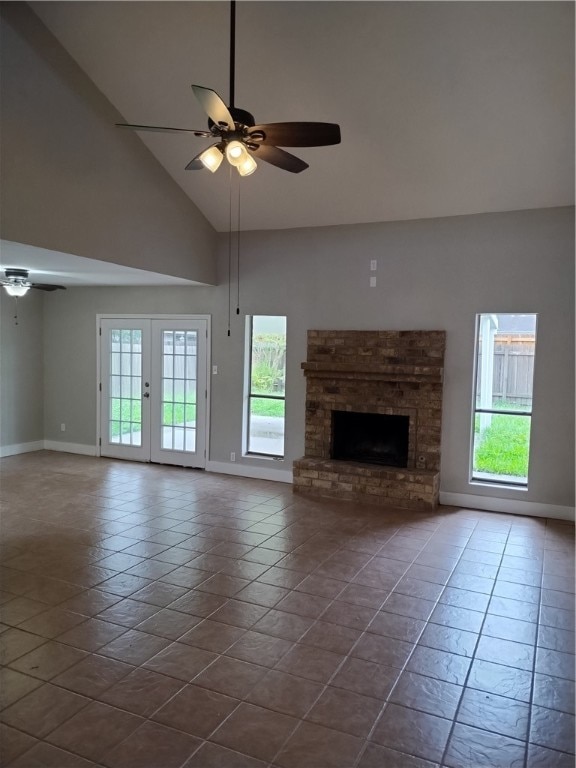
[474,415,531,477]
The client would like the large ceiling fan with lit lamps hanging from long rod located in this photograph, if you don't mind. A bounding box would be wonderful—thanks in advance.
[116,0,340,176]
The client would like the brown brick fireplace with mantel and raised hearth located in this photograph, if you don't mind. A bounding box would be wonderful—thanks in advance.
[294,331,446,510]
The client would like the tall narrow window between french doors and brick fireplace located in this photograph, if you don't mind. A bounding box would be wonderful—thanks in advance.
[246,315,286,458]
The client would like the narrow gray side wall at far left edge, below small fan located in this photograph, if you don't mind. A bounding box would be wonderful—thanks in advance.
[0,289,44,447]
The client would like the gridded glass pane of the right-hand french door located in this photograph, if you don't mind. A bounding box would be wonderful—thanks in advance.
[161,330,198,453]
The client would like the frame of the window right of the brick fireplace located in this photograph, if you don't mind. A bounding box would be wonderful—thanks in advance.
[468,312,538,491]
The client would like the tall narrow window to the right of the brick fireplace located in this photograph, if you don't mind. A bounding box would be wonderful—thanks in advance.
[471,314,536,487]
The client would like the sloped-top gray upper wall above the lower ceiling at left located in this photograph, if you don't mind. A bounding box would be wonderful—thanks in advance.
[0,3,216,284]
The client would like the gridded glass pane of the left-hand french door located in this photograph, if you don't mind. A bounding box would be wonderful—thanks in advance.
[108,328,142,447]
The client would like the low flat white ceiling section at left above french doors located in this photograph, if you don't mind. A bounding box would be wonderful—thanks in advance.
[0,240,199,287]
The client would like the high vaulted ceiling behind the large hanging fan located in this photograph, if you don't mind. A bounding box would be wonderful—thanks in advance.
[32,0,574,231]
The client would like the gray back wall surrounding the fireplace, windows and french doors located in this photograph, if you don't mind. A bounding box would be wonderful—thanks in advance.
[39,208,574,506]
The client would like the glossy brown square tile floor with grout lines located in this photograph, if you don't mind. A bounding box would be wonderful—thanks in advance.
[0,452,574,768]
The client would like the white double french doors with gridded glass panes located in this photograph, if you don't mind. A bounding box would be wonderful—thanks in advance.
[99,317,208,468]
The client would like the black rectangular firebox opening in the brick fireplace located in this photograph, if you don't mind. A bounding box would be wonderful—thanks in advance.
[330,411,410,467]
